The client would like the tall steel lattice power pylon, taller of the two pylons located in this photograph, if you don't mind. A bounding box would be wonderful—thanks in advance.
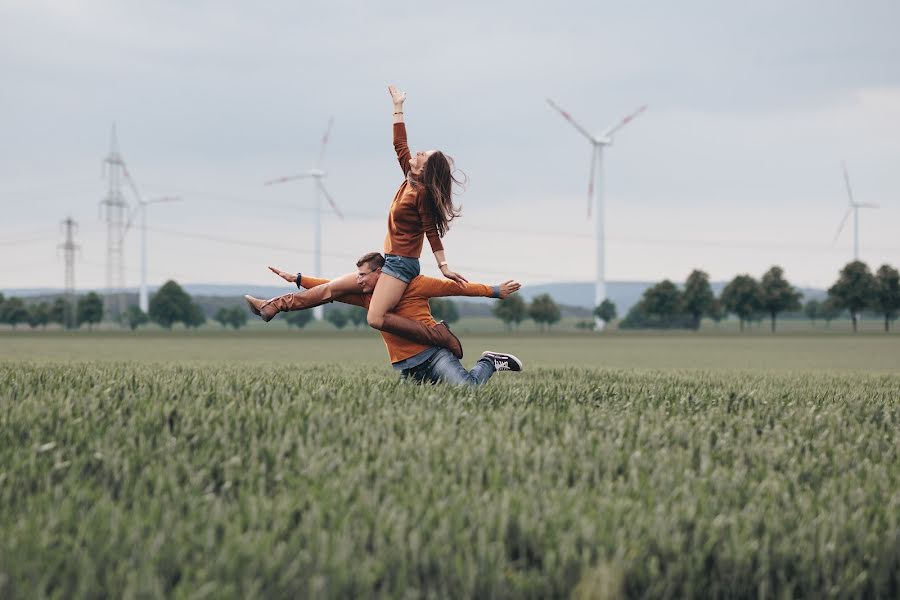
[100,123,128,320]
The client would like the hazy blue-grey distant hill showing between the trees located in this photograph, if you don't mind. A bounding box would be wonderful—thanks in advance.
[0,281,826,318]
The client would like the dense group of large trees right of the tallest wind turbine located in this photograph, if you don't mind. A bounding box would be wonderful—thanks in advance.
[620,261,900,332]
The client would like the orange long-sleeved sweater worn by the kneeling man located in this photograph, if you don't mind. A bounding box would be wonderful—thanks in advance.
[300,275,494,363]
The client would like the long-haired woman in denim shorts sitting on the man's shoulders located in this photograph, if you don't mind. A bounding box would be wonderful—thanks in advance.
[245,85,467,357]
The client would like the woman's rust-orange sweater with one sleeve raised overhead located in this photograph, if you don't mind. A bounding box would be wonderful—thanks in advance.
[384,123,444,258]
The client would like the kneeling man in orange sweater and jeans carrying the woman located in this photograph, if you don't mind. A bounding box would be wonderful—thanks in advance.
[264,252,522,385]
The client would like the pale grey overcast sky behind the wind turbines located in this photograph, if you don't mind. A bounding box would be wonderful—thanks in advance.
[0,0,900,289]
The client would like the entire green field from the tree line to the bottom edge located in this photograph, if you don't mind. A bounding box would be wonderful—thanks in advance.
[0,325,900,598]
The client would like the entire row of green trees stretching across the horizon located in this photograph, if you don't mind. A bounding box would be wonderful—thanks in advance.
[0,261,900,332]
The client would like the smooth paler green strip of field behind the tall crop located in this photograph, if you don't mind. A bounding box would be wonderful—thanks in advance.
[0,320,900,377]
